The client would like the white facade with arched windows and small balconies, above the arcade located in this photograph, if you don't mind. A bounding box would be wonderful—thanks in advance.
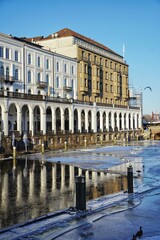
[0,34,77,99]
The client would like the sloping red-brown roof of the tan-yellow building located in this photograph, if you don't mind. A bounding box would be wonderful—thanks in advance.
[28,28,122,57]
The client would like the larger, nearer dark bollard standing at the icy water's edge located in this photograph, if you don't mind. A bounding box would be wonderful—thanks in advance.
[76,176,86,210]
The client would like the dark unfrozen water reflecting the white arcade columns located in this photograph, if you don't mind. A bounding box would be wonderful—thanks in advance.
[0,158,127,228]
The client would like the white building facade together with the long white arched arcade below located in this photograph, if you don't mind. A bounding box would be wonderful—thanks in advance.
[0,31,142,136]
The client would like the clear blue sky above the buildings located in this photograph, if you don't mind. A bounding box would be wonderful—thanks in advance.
[0,0,160,114]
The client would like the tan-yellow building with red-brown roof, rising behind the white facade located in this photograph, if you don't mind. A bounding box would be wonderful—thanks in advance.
[30,28,129,106]
